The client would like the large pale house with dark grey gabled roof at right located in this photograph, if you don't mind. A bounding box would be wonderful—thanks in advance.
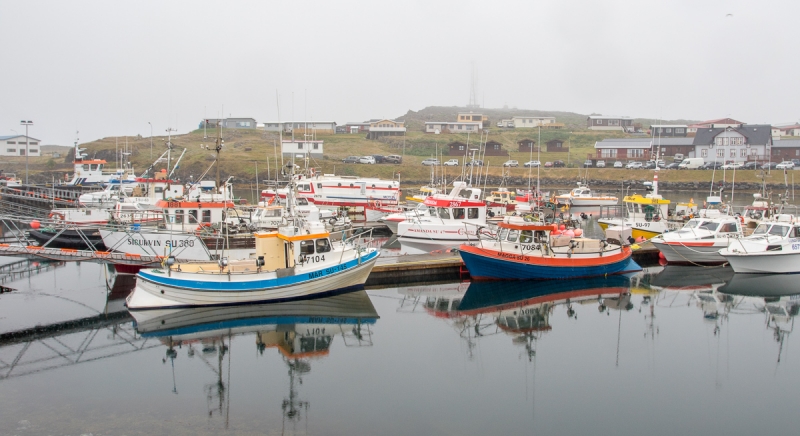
[692,124,777,162]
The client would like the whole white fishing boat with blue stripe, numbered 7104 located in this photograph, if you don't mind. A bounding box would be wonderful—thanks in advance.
[128,175,379,310]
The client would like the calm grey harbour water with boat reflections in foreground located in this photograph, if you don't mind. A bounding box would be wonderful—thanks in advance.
[0,252,800,435]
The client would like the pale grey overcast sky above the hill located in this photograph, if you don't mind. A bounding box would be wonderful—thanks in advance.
[0,0,800,145]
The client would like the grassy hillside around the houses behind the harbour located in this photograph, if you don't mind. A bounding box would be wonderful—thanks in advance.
[2,107,791,191]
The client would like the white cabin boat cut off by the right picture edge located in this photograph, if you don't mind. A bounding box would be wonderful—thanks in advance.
[719,214,800,274]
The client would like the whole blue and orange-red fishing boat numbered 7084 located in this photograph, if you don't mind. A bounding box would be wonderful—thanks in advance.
[459,217,641,280]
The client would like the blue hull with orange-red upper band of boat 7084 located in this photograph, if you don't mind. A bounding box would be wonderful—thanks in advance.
[459,245,641,280]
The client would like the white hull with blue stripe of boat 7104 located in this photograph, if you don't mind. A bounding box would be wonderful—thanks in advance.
[127,251,378,310]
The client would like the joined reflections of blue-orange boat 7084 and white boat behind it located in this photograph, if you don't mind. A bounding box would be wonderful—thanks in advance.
[399,275,633,359]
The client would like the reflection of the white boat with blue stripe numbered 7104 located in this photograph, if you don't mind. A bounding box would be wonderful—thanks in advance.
[131,290,379,428]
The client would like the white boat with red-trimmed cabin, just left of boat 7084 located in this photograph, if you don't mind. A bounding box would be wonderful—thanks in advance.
[396,181,488,242]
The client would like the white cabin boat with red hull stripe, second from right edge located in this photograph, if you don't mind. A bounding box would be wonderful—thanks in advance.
[650,209,744,264]
